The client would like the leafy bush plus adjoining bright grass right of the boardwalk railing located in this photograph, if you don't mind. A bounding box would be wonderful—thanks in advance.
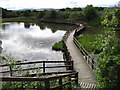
[77,9,120,89]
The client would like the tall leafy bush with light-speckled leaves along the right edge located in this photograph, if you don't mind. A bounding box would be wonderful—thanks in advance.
[97,9,120,90]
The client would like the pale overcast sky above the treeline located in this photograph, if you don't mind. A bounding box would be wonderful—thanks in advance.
[0,0,120,10]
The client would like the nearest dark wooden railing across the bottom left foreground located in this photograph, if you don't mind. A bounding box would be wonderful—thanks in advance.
[0,72,78,90]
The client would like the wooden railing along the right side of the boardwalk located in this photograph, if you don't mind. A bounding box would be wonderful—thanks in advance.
[73,37,97,71]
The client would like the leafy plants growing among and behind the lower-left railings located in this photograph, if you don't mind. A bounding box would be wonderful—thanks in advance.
[0,54,77,90]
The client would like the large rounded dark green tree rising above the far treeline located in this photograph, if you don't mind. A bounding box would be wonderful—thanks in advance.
[84,5,97,21]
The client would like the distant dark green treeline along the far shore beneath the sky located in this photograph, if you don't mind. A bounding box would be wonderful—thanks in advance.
[2,5,104,21]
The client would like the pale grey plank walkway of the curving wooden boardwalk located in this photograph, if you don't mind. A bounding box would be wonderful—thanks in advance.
[66,30,96,85]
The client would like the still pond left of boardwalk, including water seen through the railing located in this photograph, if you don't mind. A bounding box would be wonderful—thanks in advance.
[0,22,73,76]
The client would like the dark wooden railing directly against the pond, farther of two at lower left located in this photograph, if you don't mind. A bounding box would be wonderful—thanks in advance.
[0,61,73,76]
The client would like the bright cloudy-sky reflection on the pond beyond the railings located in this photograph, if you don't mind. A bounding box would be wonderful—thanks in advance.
[1,23,65,60]
